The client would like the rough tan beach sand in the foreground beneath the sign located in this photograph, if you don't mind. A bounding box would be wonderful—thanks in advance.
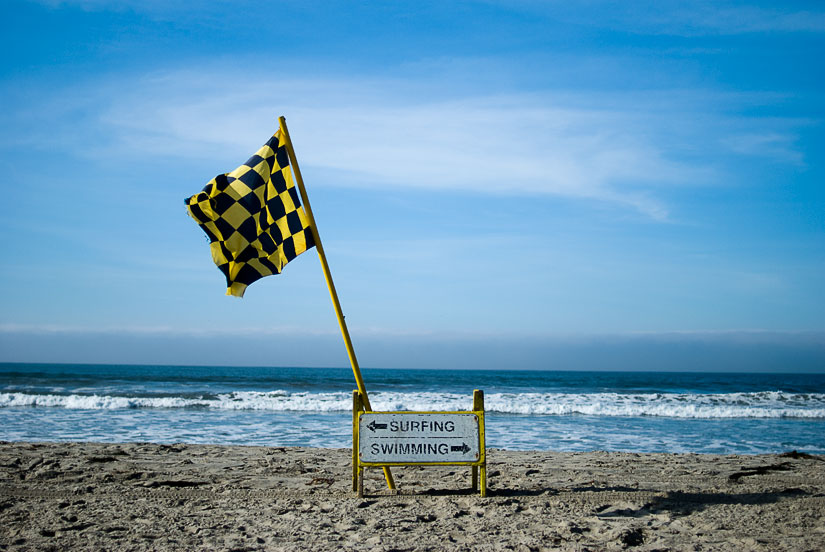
[0,443,825,551]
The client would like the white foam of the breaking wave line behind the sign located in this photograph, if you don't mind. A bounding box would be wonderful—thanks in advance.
[0,390,825,418]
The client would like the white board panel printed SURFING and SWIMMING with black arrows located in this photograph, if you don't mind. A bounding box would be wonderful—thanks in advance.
[358,412,479,463]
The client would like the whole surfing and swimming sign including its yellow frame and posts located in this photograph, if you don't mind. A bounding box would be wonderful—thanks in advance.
[352,390,487,497]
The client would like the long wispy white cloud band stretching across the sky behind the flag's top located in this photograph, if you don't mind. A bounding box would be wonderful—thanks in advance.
[1,61,801,220]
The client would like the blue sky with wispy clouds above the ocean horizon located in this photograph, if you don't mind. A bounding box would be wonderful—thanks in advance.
[0,0,825,372]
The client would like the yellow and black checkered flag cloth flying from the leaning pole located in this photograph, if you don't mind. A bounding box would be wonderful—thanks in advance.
[186,130,315,297]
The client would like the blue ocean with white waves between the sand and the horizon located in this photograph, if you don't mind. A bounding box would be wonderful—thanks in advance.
[0,363,825,454]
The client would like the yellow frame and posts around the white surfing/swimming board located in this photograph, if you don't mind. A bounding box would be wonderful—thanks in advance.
[352,389,487,498]
